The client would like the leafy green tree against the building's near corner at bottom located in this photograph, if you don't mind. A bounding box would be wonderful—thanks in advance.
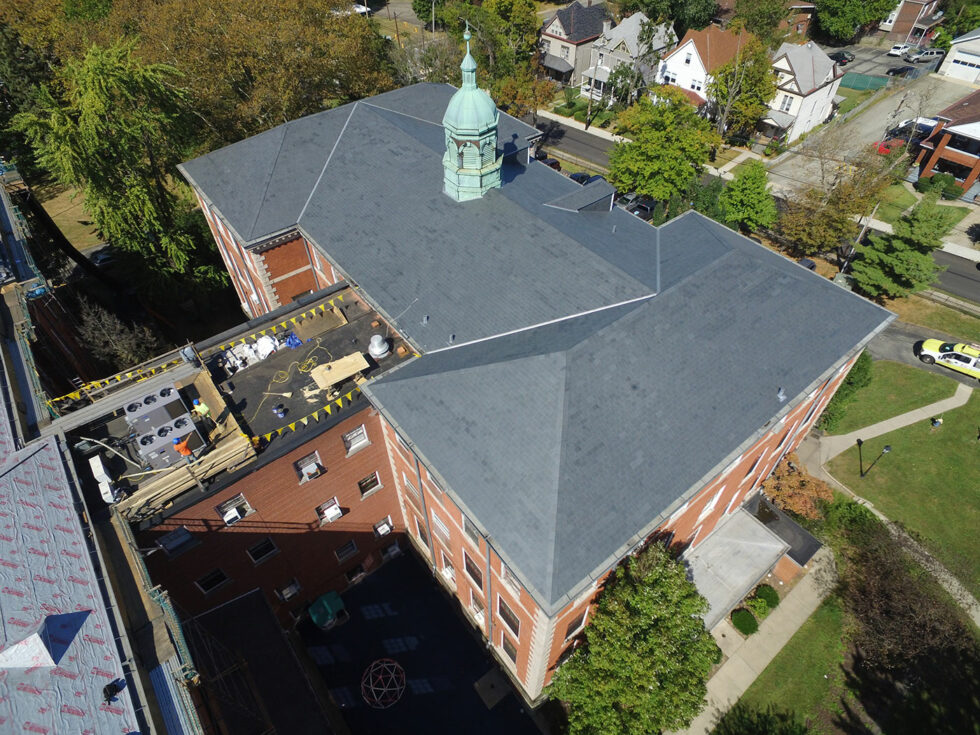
[549,544,720,735]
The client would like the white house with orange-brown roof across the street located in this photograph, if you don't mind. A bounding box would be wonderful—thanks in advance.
[657,25,752,107]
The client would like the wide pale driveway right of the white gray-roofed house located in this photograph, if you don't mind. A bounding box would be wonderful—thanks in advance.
[769,74,973,196]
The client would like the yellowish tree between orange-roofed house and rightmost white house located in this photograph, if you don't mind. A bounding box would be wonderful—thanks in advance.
[708,32,776,135]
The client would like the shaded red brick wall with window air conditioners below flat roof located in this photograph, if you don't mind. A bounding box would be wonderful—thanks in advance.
[139,408,405,625]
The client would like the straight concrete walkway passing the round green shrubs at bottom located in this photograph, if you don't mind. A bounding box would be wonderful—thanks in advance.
[673,546,837,735]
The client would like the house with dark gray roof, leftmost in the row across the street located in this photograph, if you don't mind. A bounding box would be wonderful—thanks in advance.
[539,0,612,84]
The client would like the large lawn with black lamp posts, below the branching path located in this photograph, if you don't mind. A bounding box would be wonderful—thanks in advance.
[828,391,980,596]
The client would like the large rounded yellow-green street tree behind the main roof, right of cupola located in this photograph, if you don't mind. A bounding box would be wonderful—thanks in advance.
[609,86,721,206]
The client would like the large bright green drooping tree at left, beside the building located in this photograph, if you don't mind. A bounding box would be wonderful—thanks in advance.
[13,44,211,282]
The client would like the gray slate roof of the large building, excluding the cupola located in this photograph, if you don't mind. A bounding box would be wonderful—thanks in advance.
[183,80,890,610]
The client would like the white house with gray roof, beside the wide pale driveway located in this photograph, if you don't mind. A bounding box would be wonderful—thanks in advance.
[761,41,844,142]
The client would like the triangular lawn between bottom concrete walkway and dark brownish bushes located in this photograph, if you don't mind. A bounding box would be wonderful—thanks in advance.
[739,597,844,733]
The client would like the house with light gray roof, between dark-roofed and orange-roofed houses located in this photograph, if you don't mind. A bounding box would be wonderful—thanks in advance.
[581,12,677,99]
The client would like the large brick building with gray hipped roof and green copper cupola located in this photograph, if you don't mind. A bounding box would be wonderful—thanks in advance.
[180,43,893,703]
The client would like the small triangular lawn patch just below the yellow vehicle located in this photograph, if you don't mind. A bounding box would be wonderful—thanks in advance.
[830,360,956,434]
